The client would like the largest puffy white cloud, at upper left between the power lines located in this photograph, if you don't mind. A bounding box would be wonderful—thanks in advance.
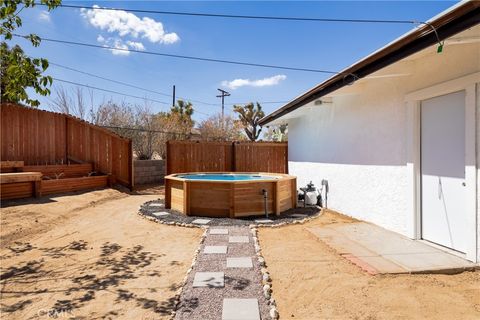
[81,5,180,44]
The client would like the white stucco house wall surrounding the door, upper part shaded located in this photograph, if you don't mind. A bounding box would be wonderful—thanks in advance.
[288,42,480,256]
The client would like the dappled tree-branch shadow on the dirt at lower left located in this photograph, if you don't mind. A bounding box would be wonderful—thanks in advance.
[0,240,178,317]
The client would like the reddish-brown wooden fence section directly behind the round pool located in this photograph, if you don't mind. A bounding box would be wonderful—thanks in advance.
[166,141,288,174]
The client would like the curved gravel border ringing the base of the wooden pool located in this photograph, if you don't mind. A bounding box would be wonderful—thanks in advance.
[140,199,320,227]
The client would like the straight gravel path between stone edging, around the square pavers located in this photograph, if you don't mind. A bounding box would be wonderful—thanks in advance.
[175,226,270,320]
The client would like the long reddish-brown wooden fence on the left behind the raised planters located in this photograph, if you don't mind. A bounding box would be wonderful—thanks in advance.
[1,103,133,188]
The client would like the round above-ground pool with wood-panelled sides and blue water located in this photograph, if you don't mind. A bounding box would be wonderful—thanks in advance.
[165,172,297,218]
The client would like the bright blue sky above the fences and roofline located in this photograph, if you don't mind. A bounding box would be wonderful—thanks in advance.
[11,1,455,121]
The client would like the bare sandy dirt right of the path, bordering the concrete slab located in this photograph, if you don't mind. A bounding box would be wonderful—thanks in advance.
[259,212,480,319]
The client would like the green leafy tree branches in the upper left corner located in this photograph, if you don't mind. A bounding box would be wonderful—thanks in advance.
[0,0,61,107]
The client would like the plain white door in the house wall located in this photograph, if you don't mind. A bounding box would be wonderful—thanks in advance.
[421,91,467,252]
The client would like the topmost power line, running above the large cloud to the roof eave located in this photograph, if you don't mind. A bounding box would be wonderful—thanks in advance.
[37,3,425,24]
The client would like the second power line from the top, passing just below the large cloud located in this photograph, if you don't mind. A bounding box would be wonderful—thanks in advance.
[12,34,342,74]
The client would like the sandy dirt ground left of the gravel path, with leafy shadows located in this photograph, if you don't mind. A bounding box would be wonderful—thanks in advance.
[0,189,202,319]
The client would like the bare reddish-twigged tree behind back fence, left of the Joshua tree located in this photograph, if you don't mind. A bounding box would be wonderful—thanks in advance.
[198,114,245,141]
